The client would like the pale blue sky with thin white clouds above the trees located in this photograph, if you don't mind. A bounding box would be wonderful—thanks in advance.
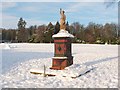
[0,2,118,28]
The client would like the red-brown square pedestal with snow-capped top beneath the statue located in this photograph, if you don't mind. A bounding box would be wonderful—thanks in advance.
[50,30,74,70]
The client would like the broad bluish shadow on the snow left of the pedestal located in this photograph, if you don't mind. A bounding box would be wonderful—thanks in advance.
[2,50,53,73]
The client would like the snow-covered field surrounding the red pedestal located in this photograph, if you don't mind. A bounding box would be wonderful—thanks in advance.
[0,43,118,88]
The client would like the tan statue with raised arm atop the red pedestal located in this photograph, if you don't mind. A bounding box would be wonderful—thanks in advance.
[60,8,66,30]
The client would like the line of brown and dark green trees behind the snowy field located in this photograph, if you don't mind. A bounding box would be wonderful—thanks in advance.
[2,18,120,44]
